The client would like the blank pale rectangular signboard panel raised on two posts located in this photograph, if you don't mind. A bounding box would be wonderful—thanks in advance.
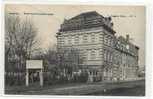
[26,60,43,69]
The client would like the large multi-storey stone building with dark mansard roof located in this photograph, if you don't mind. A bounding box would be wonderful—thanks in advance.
[57,11,139,81]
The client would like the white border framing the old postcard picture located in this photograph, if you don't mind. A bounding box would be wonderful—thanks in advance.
[0,0,153,99]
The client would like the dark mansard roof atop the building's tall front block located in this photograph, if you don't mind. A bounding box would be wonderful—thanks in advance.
[60,11,115,34]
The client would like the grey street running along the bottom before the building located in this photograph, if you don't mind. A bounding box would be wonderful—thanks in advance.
[5,80,145,96]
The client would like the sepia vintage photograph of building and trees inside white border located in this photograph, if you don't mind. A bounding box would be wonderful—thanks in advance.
[4,4,146,96]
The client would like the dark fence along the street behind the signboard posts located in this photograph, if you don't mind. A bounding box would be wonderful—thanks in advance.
[5,71,88,86]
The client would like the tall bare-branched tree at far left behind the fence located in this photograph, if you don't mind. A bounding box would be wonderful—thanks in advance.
[5,14,38,70]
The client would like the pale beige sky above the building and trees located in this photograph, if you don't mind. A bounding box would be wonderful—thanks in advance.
[5,4,146,66]
